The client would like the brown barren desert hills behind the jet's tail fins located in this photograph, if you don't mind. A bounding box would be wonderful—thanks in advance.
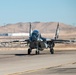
[0,22,76,33]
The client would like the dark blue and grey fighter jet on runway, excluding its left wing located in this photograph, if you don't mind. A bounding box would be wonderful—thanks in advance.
[26,23,75,55]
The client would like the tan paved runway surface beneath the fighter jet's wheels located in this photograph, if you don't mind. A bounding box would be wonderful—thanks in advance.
[0,50,76,75]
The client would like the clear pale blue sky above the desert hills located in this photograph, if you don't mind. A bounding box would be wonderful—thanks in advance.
[0,0,76,25]
